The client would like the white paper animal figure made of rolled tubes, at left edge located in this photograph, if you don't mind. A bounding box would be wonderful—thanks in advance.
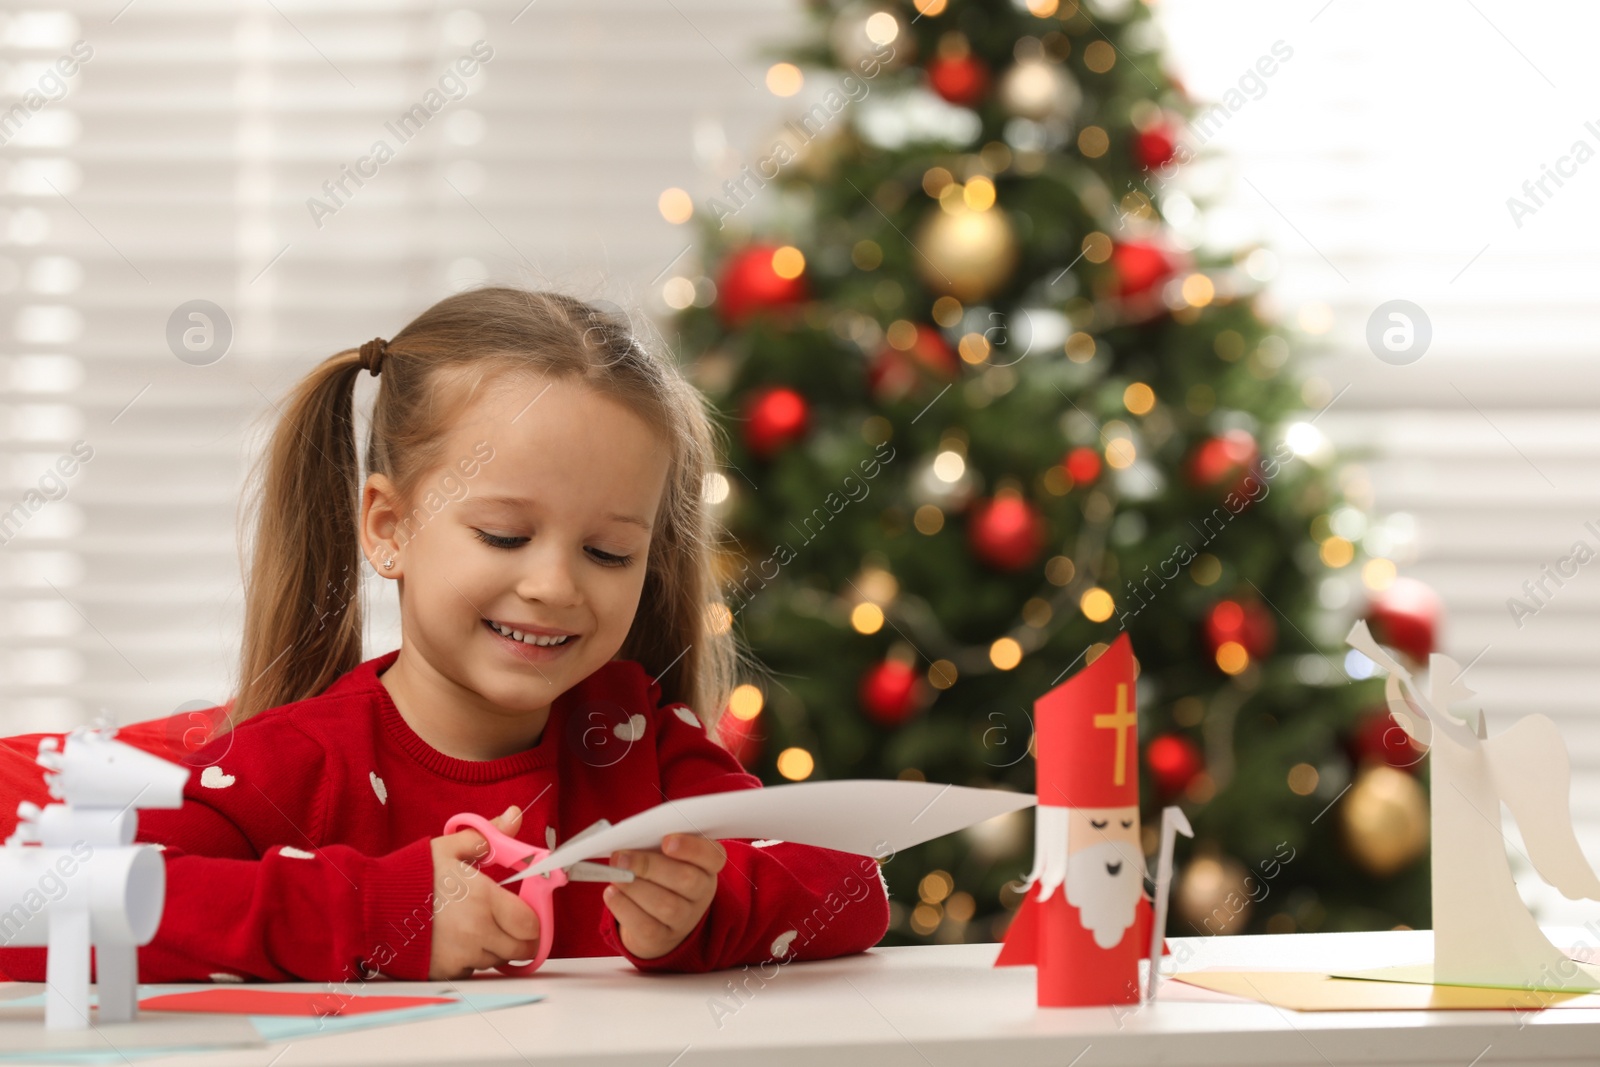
[0,728,189,1030]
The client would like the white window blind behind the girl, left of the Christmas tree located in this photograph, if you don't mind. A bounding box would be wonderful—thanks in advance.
[0,0,798,734]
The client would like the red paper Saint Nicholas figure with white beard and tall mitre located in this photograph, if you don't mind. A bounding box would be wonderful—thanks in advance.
[995,633,1152,1008]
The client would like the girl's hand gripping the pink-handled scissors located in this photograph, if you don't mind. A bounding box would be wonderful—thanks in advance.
[427,805,541,981]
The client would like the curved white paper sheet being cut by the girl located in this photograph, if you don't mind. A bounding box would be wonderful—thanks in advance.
[501,779,1037,885]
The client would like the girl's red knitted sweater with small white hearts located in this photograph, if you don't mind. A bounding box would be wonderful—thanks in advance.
[0,649,888,982]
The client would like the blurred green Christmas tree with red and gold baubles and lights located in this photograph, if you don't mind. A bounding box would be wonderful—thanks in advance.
[662,0,1437,944]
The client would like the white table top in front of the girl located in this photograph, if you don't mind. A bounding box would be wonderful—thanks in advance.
[9,929,1600,1067]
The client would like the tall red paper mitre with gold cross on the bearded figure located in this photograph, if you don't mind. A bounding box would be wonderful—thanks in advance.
[1034,633,1139,808]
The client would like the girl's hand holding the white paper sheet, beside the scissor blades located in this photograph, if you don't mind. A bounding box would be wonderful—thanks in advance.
[602,833,728,960]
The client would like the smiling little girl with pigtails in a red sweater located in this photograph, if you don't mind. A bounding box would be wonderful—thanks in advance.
[0,288,888,982]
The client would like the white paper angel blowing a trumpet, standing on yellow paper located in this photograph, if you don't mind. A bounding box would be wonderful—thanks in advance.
[1346,622,1600,990]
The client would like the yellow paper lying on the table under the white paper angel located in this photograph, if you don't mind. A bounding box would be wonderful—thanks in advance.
[1174,971,1600,1011]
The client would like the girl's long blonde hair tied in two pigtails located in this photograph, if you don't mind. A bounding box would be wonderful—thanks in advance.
[230,288,746,736]
